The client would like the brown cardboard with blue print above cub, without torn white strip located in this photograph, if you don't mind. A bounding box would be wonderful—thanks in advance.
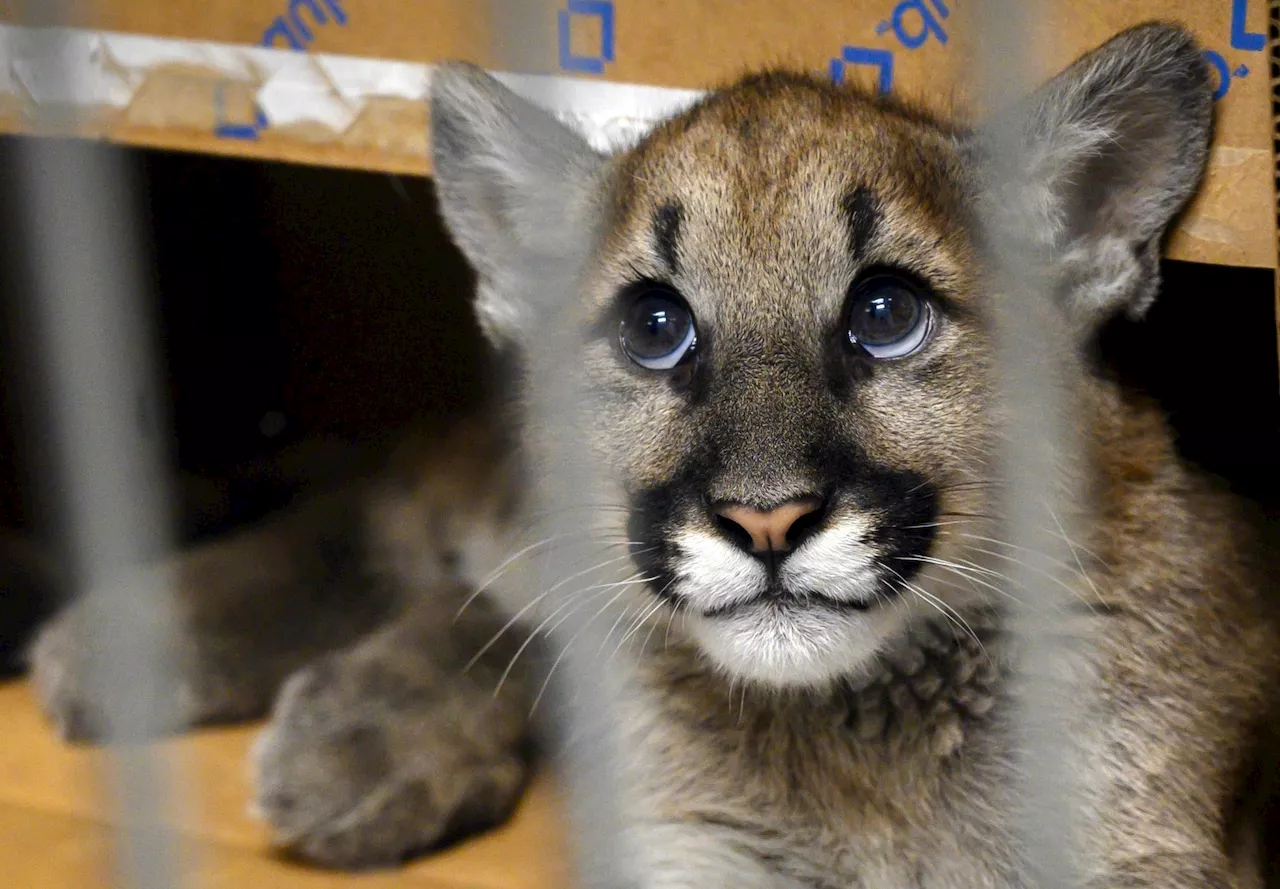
[0,0,1276,267]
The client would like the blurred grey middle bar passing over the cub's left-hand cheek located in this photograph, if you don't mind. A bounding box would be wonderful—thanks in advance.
[489,0,626,889]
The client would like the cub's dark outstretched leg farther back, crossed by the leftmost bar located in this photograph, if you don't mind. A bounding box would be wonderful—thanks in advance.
[31,487,399,741]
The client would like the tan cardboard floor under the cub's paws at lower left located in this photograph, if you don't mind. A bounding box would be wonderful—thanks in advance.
[0,683,567,889]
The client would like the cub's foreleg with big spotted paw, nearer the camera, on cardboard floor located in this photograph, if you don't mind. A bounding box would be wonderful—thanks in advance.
[253,585,532,867]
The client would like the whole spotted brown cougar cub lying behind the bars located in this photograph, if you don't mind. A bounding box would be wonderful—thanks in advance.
[27,24,1280,889]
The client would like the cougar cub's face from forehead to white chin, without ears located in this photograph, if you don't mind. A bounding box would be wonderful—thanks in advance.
[588,75,989,683]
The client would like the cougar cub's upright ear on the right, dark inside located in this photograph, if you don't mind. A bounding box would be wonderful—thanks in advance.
[978,23,1213,324]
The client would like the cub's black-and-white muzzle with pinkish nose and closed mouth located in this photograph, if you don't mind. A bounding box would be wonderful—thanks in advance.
[630,447,938,620]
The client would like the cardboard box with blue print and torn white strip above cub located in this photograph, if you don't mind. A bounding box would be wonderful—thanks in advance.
[0,0,1276,267]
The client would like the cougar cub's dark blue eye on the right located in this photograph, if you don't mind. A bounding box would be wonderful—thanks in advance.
[849,274,933,358]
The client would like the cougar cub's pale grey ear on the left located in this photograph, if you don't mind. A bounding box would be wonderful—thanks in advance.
[430,63,603,339]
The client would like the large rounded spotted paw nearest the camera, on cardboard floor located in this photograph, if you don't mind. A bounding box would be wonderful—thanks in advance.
[253,655,527,869]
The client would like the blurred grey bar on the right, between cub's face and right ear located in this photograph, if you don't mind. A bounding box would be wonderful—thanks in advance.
[973,0,1083,889]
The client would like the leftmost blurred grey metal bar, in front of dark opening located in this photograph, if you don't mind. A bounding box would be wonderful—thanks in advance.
[6,17,179,889]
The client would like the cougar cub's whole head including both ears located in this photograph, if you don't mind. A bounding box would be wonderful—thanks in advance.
[431,24,1212,684]
